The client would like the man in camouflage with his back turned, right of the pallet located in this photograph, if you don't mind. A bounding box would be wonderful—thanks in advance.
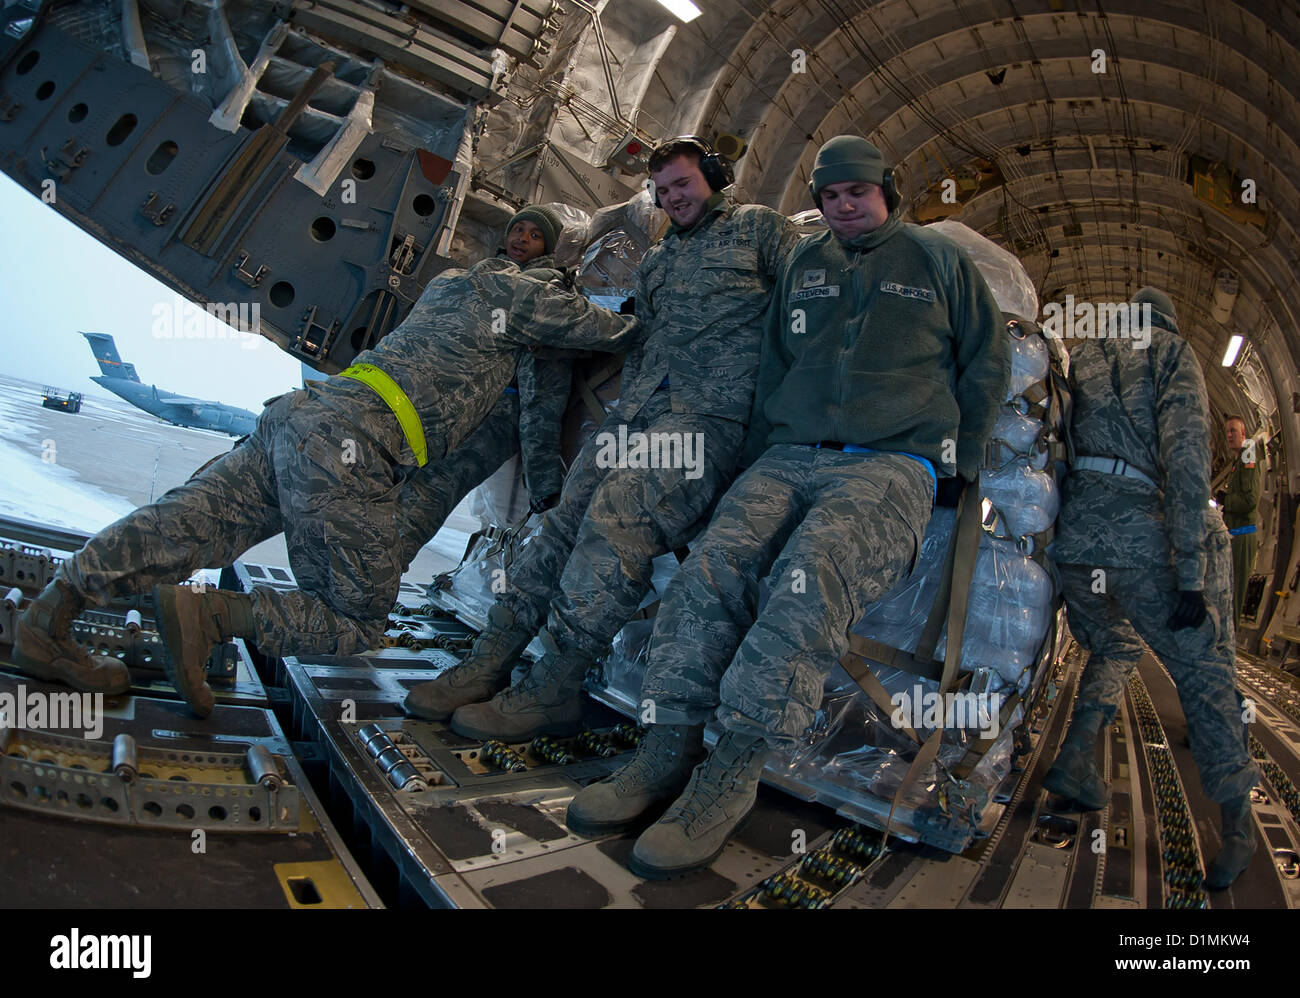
[1044,288,1258,888]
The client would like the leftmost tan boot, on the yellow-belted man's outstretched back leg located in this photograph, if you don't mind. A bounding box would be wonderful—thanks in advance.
[13,568,131,695]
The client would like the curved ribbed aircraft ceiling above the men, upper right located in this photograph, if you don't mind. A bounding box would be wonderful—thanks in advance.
[522,0,1300,467]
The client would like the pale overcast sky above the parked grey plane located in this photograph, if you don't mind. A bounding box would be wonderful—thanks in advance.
[0,168,303,412]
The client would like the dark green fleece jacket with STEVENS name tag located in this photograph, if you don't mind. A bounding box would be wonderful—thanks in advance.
[745,216,1010,481]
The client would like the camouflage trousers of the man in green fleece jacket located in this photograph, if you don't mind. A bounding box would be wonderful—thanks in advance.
[641,444,933,747]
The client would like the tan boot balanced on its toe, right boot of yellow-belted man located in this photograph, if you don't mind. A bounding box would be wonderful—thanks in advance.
[153,586,255,717]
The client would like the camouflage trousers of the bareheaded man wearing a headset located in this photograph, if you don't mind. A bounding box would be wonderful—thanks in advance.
[499,391,745,658]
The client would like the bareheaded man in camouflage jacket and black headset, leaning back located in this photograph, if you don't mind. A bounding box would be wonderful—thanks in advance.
[407,142,797,739]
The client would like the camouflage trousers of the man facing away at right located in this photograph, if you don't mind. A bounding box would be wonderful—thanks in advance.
[1058,525,1260,803]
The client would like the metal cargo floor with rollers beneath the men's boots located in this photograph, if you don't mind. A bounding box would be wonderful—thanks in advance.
[0,537,1300,910]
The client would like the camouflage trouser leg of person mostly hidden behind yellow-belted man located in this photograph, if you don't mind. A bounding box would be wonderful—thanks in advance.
[399,392,519,568]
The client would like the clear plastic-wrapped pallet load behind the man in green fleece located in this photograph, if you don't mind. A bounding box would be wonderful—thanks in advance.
[770,222,1066,845]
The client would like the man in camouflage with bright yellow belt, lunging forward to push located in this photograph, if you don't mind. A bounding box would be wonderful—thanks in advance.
[14,205,638,716]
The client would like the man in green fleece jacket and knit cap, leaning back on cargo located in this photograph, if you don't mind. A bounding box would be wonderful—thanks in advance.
[567,135,1010,878]
